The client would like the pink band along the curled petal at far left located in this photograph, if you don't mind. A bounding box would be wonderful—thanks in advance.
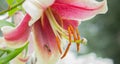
[3,14,31,44]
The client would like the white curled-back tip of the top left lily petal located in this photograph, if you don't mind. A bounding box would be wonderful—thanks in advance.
[23,0,43,26]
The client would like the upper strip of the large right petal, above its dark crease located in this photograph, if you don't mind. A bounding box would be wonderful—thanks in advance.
[55,0,106,8]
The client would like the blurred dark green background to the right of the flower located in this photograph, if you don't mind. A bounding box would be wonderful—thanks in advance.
[79,0,120,64]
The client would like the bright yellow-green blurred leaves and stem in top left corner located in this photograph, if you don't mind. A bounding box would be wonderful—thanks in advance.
[0,0,25,16]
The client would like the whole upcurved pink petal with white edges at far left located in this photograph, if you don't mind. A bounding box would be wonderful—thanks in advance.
[1,14,31,47]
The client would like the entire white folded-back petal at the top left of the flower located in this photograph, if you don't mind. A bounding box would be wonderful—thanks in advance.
[23,0,55,26]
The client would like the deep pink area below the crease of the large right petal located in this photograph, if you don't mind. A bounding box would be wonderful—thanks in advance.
[51,0,104,20]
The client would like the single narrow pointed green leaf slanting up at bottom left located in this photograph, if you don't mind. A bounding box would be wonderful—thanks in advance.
[0,42,28,64]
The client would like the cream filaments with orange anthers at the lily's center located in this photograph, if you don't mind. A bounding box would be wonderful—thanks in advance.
[45,8,81,59]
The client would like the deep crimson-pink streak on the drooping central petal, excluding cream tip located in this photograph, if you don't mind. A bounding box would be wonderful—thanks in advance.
[34,16,56,53]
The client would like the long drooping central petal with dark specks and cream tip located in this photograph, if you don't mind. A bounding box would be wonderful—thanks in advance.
[33,16,60,64]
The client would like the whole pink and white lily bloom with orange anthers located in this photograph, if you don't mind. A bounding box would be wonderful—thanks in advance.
[2,0,107,64]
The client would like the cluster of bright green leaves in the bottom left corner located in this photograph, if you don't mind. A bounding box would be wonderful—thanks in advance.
[0,42,28,64]
